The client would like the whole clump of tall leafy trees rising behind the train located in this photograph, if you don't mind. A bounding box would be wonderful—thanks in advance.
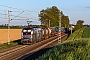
[38,6,69,27]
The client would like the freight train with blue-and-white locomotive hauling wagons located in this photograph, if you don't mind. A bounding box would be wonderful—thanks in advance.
[21,27,69,44]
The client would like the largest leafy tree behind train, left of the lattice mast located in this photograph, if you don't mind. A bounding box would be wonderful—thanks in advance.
[39,6,59,27]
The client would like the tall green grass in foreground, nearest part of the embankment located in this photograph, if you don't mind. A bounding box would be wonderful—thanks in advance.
[38,40,90,60]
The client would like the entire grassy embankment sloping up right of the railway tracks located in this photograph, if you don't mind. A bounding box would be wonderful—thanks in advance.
[38,27,90,60]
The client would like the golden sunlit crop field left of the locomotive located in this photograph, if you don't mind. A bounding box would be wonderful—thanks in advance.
[0,29,21,44]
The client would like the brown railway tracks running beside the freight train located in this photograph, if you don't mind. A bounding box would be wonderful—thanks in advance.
[0,34,67,60]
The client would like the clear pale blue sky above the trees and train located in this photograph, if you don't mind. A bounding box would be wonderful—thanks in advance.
[0,0,90,25]
